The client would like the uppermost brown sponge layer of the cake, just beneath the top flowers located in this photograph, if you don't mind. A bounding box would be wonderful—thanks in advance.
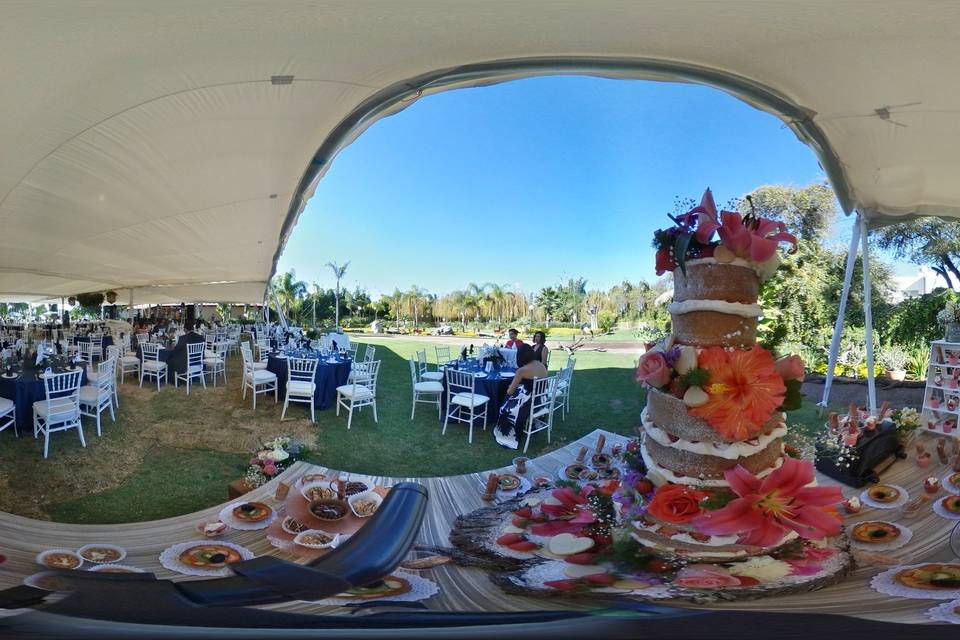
[673,258,760,304]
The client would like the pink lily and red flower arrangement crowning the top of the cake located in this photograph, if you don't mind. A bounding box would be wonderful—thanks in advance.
[653,189,797,280]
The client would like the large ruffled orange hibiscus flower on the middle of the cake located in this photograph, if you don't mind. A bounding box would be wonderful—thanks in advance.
[689,346,787,441]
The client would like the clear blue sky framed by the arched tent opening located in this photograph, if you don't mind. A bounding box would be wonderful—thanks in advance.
[279,77,849,297]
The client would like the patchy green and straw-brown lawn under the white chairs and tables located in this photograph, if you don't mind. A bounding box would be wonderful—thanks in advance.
[0,337,823,523]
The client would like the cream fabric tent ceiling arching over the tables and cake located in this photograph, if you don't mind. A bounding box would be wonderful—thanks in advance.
[0,0,960,303]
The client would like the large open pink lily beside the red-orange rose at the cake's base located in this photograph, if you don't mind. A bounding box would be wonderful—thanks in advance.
[693,457,843,547]
